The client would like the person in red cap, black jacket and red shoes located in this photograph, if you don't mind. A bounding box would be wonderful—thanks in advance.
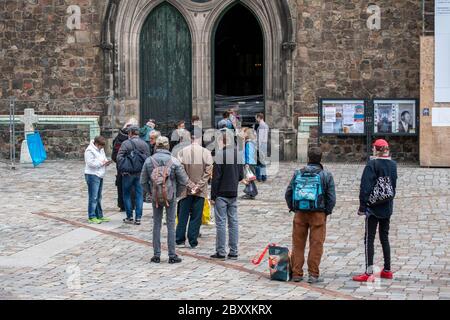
[353,139,397,282]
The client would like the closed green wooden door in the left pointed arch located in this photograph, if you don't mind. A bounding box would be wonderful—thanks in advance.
[140,2,192,134]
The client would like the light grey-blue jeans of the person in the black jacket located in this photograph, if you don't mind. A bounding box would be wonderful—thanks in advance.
[214,197,239,256]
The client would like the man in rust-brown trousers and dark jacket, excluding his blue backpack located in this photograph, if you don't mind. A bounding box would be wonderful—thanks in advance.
[285,147,336,283]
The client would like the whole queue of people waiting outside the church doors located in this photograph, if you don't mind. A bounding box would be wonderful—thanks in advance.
[85,110,397,283]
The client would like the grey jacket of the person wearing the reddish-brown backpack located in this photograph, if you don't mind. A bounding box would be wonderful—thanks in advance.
[141,149,190,197]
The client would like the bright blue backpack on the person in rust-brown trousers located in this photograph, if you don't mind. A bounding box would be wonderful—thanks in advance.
[293,170,325,212]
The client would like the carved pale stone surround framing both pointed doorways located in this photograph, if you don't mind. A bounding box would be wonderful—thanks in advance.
[103,0,296,158]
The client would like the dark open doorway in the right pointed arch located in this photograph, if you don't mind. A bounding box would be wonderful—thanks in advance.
[212,3,265,126]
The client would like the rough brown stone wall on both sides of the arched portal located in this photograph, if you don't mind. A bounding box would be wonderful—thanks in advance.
[0,0,421,160]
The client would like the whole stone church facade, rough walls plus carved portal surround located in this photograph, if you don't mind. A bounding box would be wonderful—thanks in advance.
[0,0,422,161]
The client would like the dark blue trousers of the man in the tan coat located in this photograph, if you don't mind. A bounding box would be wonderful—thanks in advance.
[176,196,205,247]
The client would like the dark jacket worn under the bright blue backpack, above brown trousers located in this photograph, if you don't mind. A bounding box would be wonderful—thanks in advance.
[285,163,336,215]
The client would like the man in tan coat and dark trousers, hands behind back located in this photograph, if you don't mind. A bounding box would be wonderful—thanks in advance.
[176,128,214,249]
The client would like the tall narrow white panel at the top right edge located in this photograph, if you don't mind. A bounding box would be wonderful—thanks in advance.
[434,0,450,102]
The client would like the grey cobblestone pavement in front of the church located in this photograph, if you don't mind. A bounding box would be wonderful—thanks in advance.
[0,162,450,299]
